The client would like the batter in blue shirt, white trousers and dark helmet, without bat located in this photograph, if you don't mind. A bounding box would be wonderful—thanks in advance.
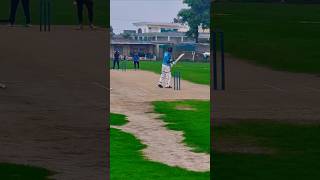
[158,47,172,88]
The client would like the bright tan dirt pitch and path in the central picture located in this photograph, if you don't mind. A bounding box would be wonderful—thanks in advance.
[110,70,210,172]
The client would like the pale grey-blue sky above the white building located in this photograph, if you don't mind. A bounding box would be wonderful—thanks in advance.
[110,0,187,34]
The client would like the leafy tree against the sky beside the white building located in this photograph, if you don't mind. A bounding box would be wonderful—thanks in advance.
[178,0,211,43]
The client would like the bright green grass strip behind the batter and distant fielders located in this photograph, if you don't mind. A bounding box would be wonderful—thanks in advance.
[111,61,210,85]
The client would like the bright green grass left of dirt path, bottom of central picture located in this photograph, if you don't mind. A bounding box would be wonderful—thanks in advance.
[110,114,210,180]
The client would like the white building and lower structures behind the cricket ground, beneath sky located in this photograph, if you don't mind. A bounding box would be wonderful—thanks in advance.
[110,22,210,60]
